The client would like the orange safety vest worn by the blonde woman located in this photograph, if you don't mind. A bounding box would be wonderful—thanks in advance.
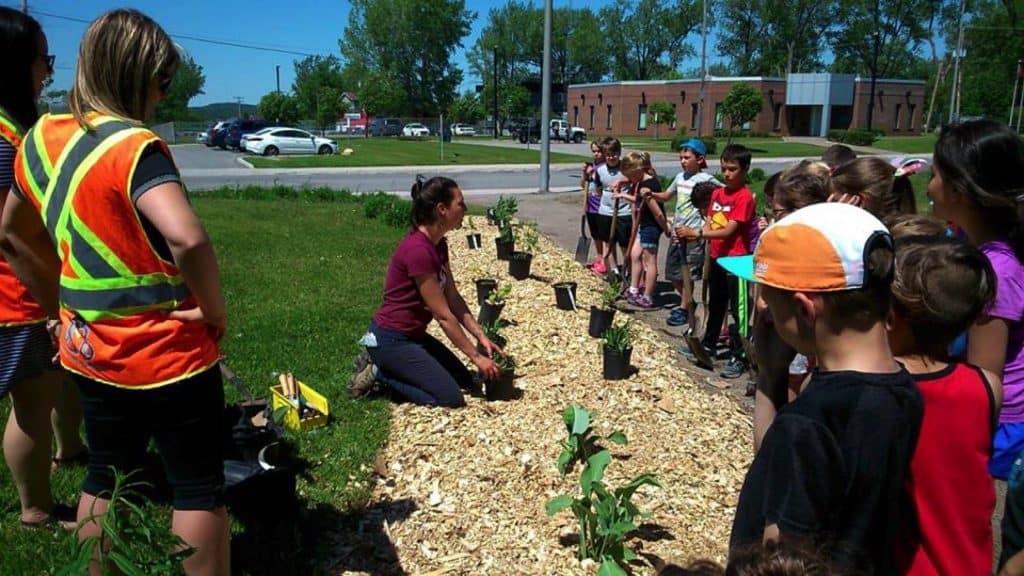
[14,114,218,388]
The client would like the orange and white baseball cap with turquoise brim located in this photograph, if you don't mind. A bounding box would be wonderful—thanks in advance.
[718,203,893,292]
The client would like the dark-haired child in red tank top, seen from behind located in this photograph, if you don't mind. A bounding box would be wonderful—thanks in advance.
[889,230,1002,576]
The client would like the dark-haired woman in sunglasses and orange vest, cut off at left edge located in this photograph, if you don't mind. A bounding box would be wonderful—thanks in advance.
[0,6,86,528]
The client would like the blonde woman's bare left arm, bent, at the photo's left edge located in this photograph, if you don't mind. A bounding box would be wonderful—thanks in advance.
[0,192,60,317]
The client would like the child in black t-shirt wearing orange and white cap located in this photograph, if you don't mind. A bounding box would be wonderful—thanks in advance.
[719,204,923,574]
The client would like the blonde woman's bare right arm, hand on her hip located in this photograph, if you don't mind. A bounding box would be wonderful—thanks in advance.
[135,182,227,337]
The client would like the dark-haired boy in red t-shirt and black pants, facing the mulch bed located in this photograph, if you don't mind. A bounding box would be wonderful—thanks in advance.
[685,145,755,378]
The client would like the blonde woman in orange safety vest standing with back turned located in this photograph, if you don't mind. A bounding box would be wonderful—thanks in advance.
[0,9,229,574]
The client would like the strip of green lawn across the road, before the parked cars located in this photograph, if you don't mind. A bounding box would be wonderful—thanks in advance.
[246,138,590,168]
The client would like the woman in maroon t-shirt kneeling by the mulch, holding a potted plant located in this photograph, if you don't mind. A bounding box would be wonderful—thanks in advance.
[349,176,501,407]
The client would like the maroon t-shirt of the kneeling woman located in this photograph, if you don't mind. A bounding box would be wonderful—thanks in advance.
[374,230,449,336]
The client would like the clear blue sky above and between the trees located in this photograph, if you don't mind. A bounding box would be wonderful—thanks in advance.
[9,0,714,106]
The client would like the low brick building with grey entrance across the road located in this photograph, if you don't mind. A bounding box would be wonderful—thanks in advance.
[566,74,925,136]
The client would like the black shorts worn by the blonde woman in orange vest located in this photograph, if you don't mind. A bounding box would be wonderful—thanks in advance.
[73,366,224,510]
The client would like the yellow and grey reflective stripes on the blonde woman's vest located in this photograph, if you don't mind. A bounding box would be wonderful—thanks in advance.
[23,117,189,322]
